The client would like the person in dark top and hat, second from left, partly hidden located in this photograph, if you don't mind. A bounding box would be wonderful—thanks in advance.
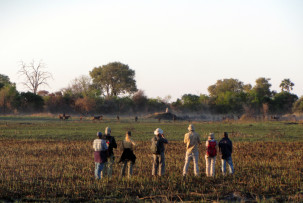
[101,127,117,177]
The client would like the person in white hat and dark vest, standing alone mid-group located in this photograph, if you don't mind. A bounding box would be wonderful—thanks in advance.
[151,128,168,176]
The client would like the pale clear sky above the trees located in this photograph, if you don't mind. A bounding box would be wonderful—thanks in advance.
[0,0,303,101]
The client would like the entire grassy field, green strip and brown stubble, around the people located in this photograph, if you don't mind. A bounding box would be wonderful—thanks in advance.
[0,117,303,202]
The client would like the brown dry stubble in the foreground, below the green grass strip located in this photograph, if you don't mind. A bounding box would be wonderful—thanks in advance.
[0,117,303,202]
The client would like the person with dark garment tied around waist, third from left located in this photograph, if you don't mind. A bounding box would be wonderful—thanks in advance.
[119,131,136,178]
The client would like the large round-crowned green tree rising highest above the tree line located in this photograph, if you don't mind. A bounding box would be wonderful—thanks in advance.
[89,62,137,97]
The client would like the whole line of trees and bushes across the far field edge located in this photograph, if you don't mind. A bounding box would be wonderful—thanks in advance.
[0,61,303,115]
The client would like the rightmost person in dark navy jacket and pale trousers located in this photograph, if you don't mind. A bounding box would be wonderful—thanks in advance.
[219,132,234,175]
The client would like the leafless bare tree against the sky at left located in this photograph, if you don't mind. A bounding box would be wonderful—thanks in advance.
[19,60,52,94]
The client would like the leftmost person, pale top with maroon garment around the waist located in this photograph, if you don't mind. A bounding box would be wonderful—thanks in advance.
[93,132,108,179]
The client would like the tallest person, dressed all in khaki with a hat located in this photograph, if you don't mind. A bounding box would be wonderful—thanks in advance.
[183,124,201,176]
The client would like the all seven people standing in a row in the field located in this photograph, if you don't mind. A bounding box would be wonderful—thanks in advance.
[93,124,234,179]
